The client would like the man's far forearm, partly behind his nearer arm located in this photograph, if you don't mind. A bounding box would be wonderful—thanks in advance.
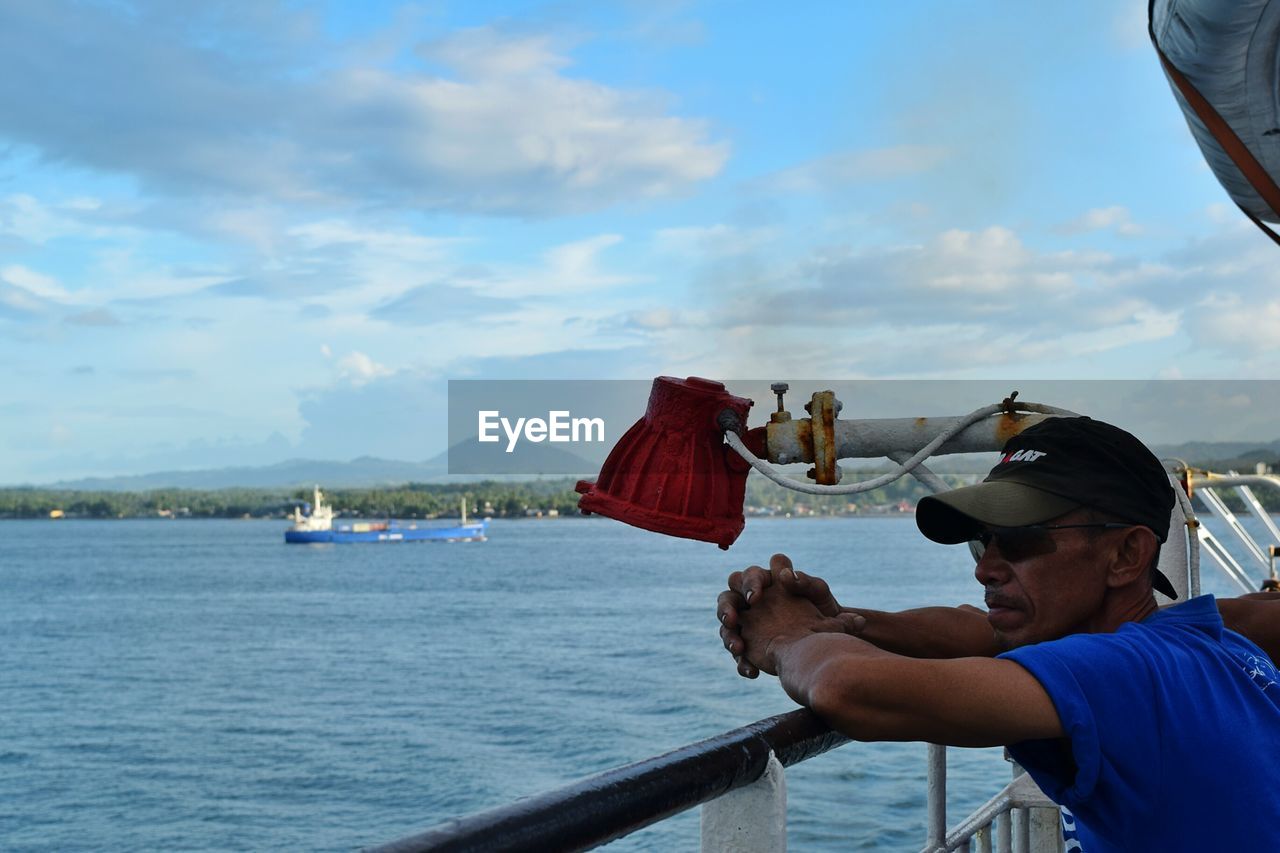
[844,607,1000,660]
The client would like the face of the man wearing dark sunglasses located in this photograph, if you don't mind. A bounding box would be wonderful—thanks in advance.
[974,511,1107,649]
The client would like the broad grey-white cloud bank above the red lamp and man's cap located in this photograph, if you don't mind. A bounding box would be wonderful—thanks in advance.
[660,227,1189,375]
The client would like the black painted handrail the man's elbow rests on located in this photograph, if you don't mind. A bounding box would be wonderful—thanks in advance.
[370,710,849,853]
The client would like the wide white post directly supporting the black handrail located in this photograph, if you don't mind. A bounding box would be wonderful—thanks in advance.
[703,752,787,853]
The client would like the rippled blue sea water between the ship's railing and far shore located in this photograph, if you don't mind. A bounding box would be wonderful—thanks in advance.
[0,516,1258,852]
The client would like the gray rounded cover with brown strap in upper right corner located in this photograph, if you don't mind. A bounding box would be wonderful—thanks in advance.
[1151,0,1280,222]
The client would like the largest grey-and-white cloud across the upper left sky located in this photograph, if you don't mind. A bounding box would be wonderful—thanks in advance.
[0,9,728,215]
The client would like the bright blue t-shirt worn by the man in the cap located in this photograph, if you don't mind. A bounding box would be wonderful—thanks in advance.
[1000,596,1280,853]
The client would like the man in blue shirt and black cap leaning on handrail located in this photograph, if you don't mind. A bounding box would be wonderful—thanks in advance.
[719,418,1280,852]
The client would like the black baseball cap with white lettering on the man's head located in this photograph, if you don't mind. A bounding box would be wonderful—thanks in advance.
[915,418,1178,598]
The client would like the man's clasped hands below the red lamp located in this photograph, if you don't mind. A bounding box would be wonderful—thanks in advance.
[716,553,864,679]
